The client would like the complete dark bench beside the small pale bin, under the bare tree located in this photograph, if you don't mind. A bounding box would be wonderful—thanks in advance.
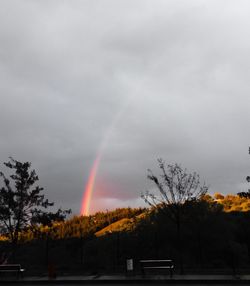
[140,259,174,278]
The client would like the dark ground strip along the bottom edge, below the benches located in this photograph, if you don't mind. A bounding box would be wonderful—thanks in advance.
[0,274,250,286]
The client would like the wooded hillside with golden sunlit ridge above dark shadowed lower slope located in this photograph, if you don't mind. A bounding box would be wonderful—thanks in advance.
[1,194,250,274]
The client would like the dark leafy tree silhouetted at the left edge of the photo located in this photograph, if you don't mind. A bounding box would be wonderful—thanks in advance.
[0,157,70,245]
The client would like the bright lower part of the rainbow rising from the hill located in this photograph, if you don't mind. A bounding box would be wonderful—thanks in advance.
[81,155,101,216]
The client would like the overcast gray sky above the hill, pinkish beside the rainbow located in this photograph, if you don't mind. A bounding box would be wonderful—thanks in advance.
[0,0,250,213]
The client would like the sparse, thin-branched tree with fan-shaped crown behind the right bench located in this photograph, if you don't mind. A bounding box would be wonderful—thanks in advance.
[142,159,208,273]
